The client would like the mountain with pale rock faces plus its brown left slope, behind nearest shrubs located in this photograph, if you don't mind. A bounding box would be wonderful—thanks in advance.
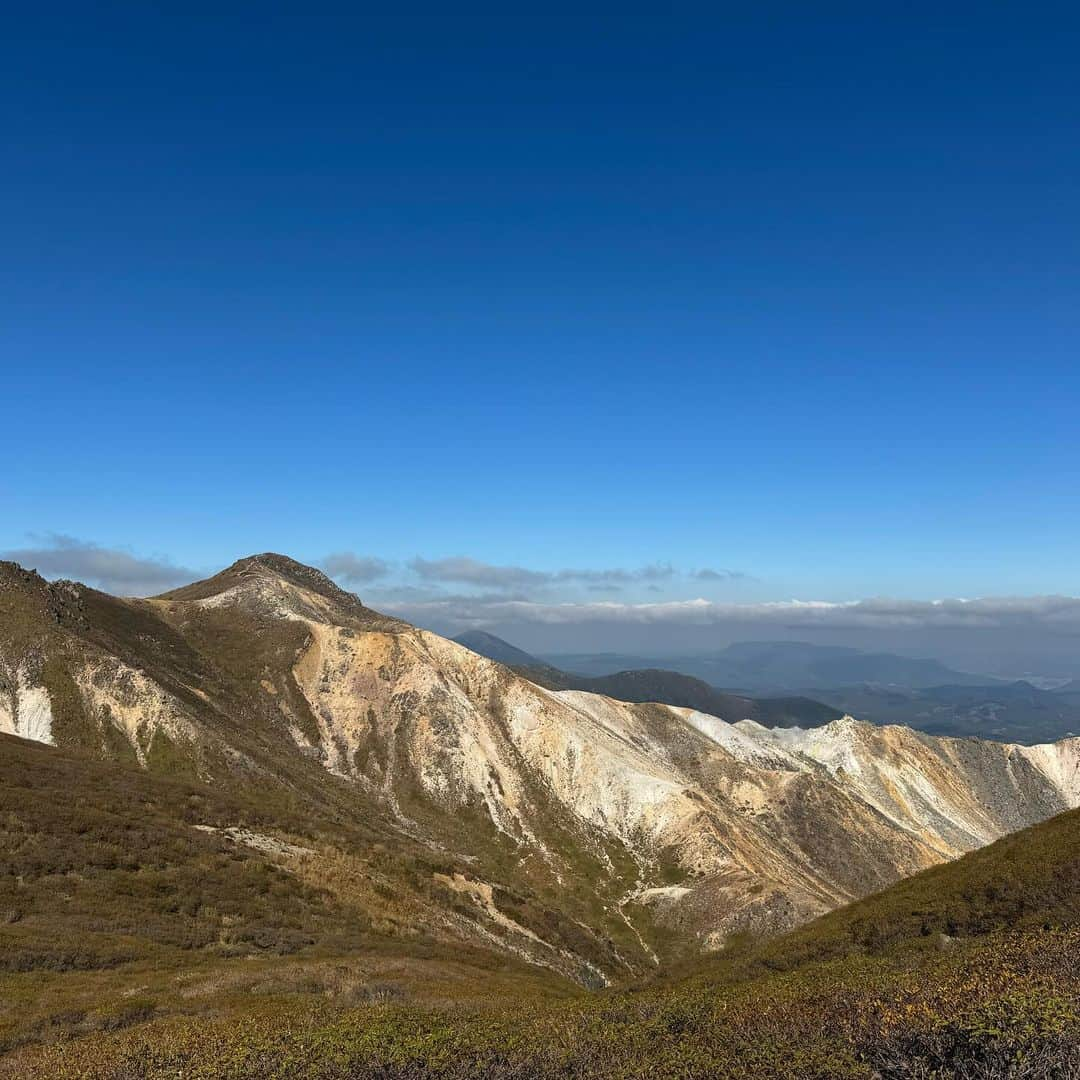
[0,554,1080,1075]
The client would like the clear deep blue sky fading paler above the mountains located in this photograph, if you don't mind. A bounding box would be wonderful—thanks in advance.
[0,4,1080,656]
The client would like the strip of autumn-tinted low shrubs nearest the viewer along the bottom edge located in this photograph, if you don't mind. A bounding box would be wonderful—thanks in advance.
[10,915,1080,1080]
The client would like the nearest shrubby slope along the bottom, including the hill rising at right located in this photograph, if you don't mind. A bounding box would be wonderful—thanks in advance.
[12,794,1080,1080]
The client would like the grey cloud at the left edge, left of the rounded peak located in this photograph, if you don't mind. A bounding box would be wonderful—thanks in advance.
[0,532,199,596]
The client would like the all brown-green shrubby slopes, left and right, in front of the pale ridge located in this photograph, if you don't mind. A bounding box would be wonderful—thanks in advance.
[6,740,1080,1080]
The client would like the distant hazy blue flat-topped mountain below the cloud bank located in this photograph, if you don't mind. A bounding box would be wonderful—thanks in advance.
[548,642,999,694]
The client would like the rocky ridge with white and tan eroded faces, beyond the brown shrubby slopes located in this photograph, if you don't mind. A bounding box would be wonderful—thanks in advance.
[0,555,1080,980]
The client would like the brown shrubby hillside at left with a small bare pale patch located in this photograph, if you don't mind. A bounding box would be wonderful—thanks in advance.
[0,735,568,1067]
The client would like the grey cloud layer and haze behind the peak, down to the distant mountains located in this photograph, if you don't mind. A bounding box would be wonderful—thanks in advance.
[6,534,1080,677]
